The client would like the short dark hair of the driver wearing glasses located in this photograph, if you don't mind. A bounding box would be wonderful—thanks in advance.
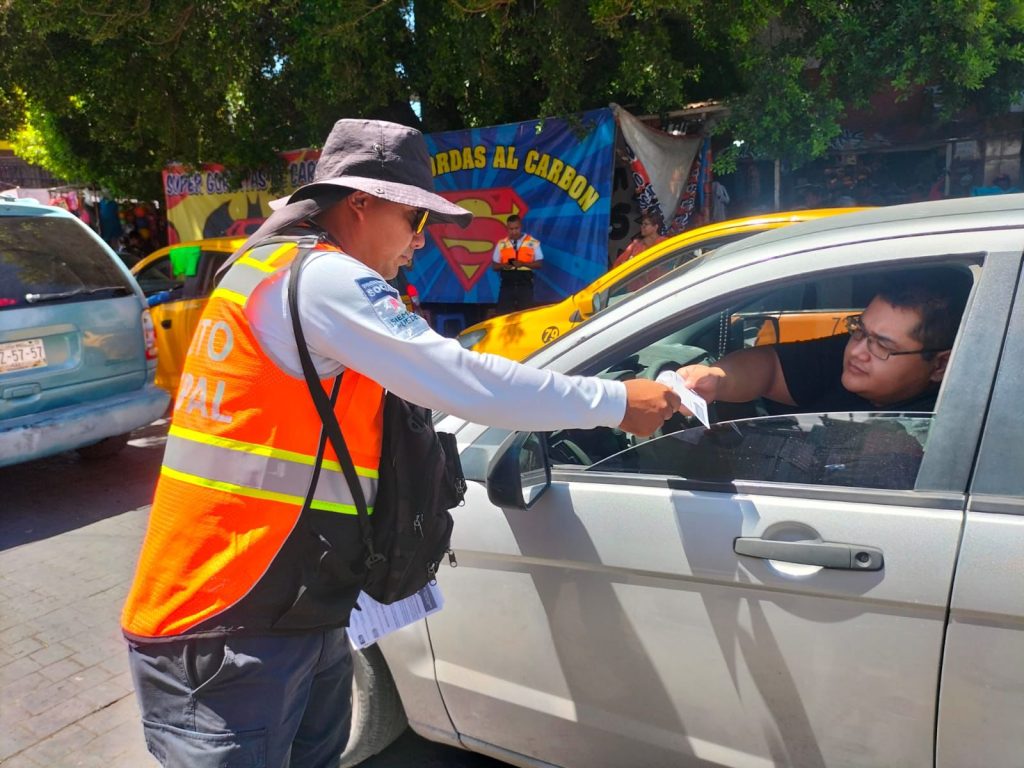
[878,270,972,359]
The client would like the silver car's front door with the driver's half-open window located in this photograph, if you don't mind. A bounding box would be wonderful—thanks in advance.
[428,237,1019,766]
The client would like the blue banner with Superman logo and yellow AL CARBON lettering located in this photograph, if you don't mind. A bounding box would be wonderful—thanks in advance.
[409,110,615,304]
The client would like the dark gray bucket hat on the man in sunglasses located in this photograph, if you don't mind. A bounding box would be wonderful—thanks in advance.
[270,120,473,226]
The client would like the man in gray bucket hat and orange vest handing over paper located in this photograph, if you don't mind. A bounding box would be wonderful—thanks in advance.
[122,120,680,768]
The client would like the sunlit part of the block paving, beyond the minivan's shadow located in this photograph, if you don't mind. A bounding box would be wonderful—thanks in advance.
[0,505,158,768]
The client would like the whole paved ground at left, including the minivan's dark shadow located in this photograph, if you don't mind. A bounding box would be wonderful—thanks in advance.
[0,419,167,768]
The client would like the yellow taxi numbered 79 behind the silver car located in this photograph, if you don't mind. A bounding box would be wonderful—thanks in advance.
[459,208,861,360]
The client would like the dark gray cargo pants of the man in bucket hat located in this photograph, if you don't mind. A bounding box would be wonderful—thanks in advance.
[128,629,352,768]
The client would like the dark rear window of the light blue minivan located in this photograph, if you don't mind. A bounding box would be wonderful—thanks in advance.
[0,216,134,311]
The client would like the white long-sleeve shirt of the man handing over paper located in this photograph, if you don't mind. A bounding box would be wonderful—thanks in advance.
[246,251,626,431]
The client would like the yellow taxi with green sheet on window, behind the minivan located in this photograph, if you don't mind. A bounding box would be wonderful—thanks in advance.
[131,238,246,396]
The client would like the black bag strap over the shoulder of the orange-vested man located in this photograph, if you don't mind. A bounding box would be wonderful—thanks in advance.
[288,248,386,569]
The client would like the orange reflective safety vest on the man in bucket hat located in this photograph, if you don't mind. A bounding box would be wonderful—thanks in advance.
[122,239,383,640]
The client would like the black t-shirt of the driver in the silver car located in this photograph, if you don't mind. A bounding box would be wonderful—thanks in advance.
[775,334,939,413]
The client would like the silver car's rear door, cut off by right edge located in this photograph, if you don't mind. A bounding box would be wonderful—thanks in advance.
[935,253,1024,768]
